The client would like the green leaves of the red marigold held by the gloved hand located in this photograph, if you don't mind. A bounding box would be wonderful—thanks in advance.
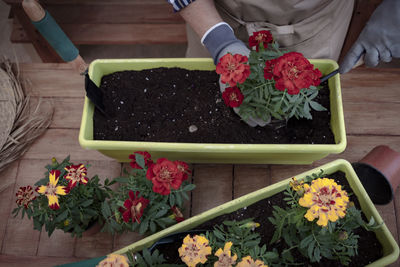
[238,42,326,121]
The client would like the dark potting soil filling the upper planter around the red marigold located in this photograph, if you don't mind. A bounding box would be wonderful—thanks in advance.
[94,68,335,144]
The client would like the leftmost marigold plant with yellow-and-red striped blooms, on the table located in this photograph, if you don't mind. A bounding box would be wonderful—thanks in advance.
[13,156,111,237]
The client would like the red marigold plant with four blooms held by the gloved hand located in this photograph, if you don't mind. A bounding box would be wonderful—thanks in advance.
[216,31,326,124]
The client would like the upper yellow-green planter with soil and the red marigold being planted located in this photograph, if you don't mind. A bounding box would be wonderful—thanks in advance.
[79,29,346,164]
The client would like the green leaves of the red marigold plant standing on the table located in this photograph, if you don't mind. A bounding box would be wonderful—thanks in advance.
[102,154,195,234]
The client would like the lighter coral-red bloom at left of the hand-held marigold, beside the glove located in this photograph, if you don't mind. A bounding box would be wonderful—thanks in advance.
[216,53,250,86]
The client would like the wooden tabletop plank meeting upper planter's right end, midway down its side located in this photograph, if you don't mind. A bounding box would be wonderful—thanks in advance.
[343,102,400,136]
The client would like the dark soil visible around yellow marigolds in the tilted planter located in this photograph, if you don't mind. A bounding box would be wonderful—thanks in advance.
[157,172,383,267]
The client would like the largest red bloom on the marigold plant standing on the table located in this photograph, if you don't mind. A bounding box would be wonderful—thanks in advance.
[146,158,183,195]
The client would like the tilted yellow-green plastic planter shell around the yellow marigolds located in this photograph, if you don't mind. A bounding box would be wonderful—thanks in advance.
[113,159,399,267]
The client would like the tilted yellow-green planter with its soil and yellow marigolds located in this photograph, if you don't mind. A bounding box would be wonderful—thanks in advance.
[108,160,399,266]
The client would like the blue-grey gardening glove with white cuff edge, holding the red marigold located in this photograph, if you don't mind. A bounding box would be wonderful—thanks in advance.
[201,22,269,127]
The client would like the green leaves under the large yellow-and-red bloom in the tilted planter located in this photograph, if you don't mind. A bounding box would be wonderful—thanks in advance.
[268,170,380,265]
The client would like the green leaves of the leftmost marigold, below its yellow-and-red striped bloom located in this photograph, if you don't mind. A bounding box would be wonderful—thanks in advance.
[13,156,111,237]
